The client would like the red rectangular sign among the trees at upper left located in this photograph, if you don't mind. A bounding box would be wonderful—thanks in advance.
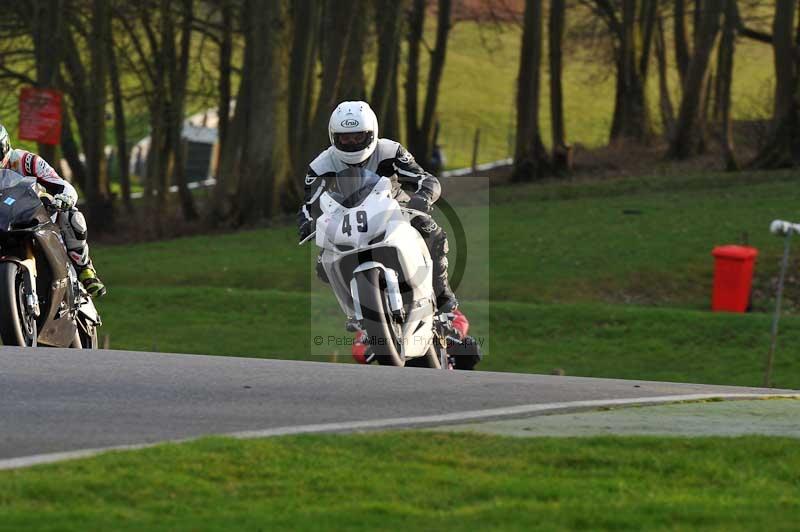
[19,87,61,144]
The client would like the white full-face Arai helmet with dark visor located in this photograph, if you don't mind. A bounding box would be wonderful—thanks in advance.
[328,102,378,165]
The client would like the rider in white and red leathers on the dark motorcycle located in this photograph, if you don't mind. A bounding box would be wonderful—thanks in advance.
[0,125,106,298]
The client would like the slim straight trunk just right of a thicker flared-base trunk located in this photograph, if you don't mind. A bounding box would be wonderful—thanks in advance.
[547,0,571,173]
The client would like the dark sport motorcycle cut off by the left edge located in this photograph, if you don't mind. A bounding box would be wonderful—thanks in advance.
[0,170,101,349]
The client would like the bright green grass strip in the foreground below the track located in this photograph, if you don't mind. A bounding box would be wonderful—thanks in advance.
[0,432,800,531]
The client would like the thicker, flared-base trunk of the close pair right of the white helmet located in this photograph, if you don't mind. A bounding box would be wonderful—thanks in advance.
[512,0,550,181]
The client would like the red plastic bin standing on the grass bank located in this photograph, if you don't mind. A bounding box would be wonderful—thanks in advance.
[711,246,758,312]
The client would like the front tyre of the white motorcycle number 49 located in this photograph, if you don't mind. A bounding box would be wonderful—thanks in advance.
[355,269,405,366]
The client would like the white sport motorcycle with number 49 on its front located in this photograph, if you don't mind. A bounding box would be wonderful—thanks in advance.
[301,168,452,369]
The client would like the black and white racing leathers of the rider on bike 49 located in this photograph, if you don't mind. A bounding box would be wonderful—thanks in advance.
[297,139,457,310]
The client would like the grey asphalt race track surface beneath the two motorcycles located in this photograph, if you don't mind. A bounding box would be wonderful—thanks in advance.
[0,347,793,467]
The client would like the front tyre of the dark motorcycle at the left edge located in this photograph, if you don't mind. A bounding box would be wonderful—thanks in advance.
[0,262,37,347]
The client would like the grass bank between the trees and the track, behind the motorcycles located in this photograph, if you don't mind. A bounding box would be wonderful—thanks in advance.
[94,168,800,388]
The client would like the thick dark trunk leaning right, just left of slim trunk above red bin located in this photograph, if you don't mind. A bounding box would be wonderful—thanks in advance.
[668,0,726,159]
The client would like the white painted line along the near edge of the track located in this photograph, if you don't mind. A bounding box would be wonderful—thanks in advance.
[0,393,800,470]
